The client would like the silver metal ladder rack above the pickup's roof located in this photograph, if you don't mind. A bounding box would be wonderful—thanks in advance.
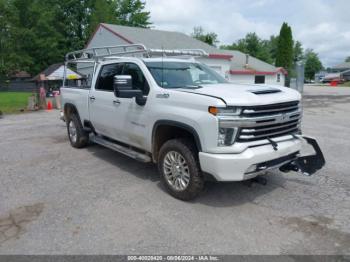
[65,44,208,63]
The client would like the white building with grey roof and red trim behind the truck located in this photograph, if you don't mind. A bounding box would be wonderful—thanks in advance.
[86,23,287,85]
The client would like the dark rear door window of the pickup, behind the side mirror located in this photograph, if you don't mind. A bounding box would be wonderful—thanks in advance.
[96,64,123,91]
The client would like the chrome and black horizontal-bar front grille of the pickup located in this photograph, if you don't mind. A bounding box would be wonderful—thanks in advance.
[237,101,301,142]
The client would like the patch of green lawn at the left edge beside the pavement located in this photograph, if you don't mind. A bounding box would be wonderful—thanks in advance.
[0,92,32,114]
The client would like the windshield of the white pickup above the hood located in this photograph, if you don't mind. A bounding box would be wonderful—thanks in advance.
[145,61,227,88]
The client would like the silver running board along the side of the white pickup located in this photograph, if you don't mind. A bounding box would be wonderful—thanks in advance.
[90,135,151,163]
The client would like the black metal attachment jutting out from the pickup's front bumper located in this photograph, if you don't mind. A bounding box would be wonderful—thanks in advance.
[280,136,326,176]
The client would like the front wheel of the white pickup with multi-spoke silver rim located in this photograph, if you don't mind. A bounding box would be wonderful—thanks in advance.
[158,139,204,201]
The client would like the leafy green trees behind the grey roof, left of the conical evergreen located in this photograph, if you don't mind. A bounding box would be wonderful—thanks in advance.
[221,33,273,63]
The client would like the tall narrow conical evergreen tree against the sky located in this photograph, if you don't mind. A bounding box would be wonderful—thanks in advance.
[276,23,293,72]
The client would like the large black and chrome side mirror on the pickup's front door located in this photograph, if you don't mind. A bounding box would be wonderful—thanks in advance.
[113,75,142,98]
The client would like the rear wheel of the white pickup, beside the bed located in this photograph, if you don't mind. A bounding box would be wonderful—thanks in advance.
[66,114,89,148]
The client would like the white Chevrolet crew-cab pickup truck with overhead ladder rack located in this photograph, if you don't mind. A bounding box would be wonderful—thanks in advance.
[61,45,325,200]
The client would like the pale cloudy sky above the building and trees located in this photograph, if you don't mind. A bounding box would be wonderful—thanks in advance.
[146,0,350,66]
